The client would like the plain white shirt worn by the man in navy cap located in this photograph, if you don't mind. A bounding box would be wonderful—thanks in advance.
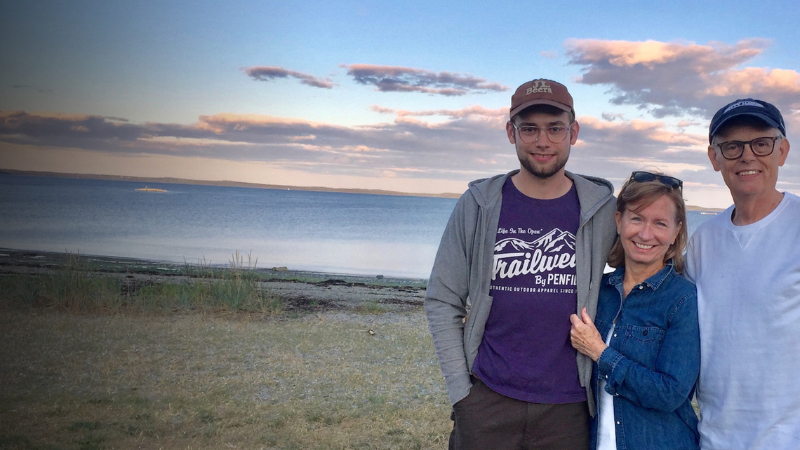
[686,193,800,450]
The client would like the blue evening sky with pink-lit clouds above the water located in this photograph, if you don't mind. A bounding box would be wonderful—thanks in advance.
[0,0,800,207]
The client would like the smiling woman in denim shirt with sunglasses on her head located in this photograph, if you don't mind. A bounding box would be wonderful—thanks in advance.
[570,172,700,450]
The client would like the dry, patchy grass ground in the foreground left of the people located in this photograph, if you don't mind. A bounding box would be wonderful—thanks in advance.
[0,304,451,449]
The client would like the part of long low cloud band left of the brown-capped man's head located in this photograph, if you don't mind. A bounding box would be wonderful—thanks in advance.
[0,107,515,180]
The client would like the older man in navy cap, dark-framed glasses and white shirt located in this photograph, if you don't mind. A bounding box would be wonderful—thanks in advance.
[686,98,800,450]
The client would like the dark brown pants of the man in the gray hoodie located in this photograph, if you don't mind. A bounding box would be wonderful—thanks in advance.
[449,378,589,450]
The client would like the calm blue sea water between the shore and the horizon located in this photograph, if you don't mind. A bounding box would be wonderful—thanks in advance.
[0,174,712,278]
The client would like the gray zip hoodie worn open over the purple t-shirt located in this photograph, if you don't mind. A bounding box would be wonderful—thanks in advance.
[425,171,616,416]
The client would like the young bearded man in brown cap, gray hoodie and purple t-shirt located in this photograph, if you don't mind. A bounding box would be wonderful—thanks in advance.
[425,79,616,450]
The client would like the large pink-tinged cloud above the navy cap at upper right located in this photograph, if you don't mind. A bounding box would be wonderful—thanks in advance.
[565,39,800,118]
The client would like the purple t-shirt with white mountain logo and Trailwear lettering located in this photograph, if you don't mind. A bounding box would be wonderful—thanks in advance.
[472,177,586,404]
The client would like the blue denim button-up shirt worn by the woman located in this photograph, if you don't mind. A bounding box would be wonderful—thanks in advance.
[591,260,700,450]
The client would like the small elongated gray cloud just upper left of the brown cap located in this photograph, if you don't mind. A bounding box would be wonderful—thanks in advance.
[343,64,508,96]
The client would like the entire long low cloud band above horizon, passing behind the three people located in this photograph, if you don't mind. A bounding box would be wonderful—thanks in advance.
[0,106,800,204]
